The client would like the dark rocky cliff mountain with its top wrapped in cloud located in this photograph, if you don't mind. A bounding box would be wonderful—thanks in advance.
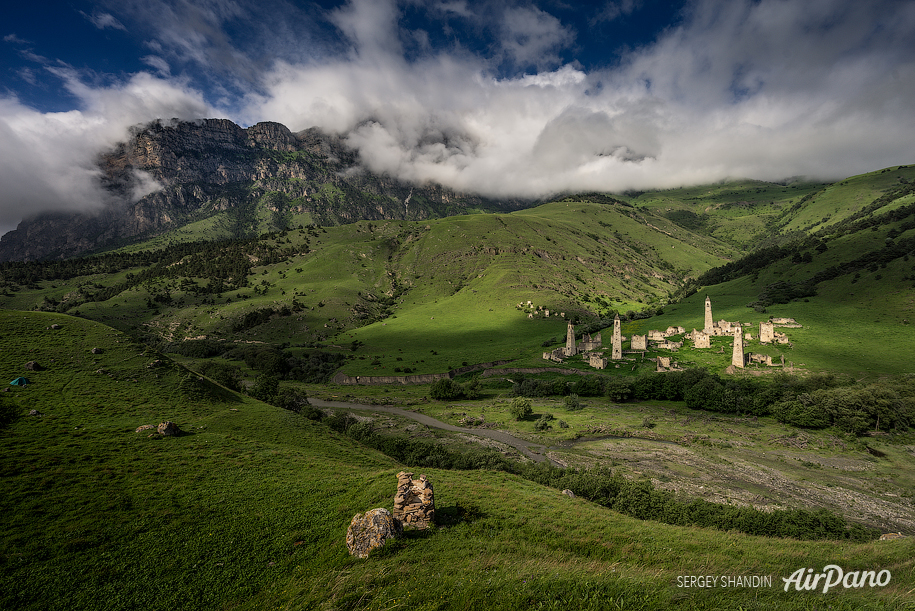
[0,119,528,261]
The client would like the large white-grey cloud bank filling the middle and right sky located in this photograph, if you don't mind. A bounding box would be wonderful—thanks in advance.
[236,0,915,196]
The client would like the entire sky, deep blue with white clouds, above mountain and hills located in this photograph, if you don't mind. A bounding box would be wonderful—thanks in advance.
[0,0,915,231]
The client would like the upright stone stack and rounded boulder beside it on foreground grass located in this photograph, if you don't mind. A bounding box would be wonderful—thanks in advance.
[346,472,435,558]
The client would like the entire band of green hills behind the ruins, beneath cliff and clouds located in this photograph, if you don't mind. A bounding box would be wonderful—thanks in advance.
[0,166,915,376]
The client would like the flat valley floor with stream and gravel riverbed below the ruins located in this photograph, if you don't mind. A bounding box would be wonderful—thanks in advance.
[310,398,915,535]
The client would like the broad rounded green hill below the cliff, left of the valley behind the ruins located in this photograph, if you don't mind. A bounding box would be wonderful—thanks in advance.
[0,196,734,375]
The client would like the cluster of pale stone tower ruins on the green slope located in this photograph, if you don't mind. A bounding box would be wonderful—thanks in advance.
[540,297,801,371]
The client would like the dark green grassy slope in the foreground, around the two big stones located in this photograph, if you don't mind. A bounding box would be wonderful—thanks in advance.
[0,312,915,610]
